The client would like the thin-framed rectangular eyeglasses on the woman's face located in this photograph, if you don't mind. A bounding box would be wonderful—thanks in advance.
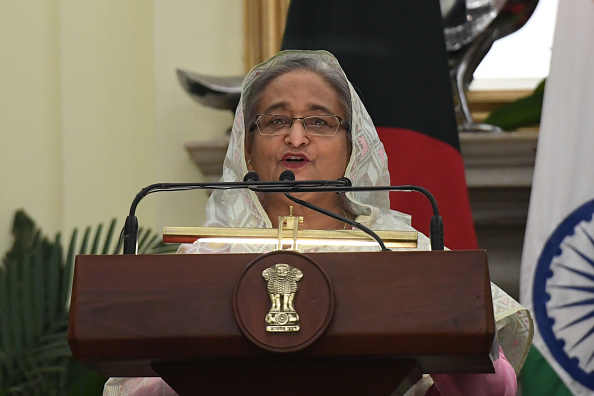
[256,114,346,136]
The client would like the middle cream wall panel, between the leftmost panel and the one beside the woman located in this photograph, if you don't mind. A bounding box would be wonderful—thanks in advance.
[60,0,155,240]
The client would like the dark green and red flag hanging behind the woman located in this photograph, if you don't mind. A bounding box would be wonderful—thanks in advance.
[282,0,477,249]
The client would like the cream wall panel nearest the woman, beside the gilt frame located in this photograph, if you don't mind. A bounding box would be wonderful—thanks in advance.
[153,0,243,232]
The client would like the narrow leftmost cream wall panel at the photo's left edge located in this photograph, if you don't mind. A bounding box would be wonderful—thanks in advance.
[0,0,63,255]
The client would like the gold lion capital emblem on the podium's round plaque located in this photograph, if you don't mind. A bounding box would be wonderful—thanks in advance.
[262,264,303,333]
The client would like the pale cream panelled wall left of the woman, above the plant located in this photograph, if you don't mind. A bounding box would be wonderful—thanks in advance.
[0,0,243,254]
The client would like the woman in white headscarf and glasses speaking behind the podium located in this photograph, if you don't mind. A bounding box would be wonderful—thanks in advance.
[104,51,532,396]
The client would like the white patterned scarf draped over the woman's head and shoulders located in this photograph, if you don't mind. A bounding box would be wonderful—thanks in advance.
[193,51,416,251]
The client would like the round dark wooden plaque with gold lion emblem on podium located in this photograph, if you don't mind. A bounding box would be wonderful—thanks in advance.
[233,250,334,352]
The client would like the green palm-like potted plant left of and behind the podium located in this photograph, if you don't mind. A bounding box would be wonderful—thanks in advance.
[0,211,166,396]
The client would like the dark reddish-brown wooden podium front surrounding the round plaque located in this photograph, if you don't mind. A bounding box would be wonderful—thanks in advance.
[68,250,495,377]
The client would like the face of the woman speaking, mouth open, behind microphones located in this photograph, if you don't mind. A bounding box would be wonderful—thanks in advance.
[246,70,350,181]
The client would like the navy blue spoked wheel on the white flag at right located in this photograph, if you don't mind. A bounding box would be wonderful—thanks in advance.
[533,200,594,390]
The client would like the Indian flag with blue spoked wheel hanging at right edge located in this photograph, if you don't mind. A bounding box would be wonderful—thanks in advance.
[520,0,594,396]
